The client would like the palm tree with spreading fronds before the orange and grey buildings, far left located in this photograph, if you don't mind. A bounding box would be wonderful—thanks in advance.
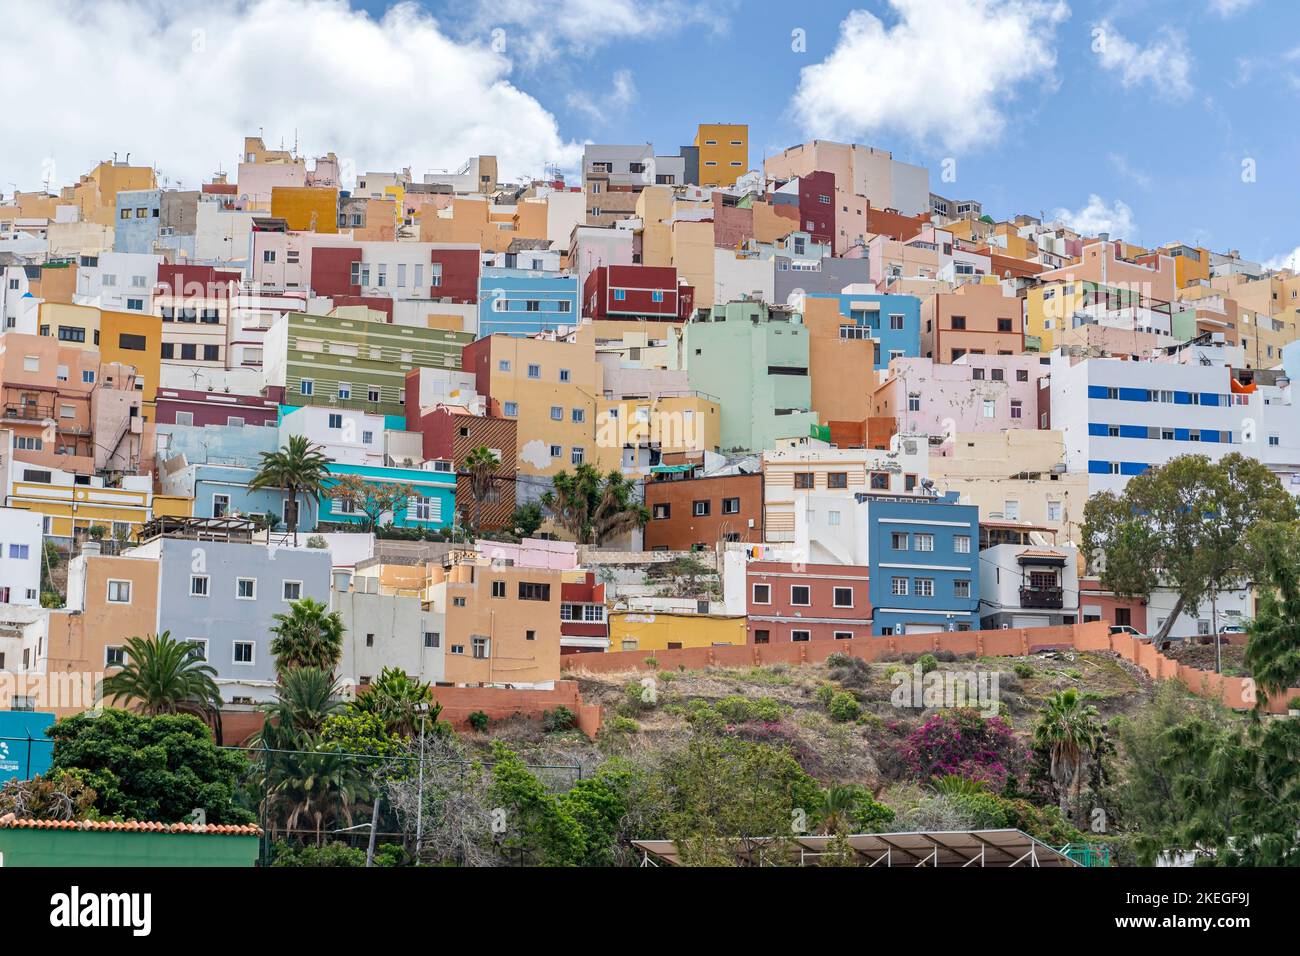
[100,631,221,741]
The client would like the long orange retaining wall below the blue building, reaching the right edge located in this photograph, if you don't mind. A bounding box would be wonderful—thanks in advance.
[561,620,1300,714]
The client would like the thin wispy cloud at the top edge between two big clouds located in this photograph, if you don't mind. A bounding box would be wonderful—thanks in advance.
[465,0,732,68]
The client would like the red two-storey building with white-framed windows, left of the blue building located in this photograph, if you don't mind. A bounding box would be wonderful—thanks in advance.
[745,561,871,644]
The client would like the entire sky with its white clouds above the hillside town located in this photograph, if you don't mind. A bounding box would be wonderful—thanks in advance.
[10,0,1300,269]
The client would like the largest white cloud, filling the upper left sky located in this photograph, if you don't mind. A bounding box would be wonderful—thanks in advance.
[0,0,581,195]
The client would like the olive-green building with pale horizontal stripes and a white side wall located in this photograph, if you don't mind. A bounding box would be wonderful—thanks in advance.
[263,307,475,416]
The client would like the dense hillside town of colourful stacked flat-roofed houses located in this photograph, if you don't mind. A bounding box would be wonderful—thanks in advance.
[0,117,1300,865]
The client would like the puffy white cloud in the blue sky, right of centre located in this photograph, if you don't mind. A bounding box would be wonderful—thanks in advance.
[790,0,1070,150]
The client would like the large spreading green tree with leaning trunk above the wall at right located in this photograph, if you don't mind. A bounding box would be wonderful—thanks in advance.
[1083,453,1296,640]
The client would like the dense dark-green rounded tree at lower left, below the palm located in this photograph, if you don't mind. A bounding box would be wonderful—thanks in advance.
[46,709,254,823]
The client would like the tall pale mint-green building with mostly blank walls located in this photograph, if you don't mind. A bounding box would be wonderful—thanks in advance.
[683,302,818,453]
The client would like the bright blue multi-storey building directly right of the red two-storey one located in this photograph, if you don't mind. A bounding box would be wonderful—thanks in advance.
[857,492,979,635]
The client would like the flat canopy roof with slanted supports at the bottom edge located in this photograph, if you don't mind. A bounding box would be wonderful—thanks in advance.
[632,830,1080,868]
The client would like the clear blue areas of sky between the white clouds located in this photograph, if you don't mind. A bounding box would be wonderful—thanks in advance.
[408,0,1300,265]
